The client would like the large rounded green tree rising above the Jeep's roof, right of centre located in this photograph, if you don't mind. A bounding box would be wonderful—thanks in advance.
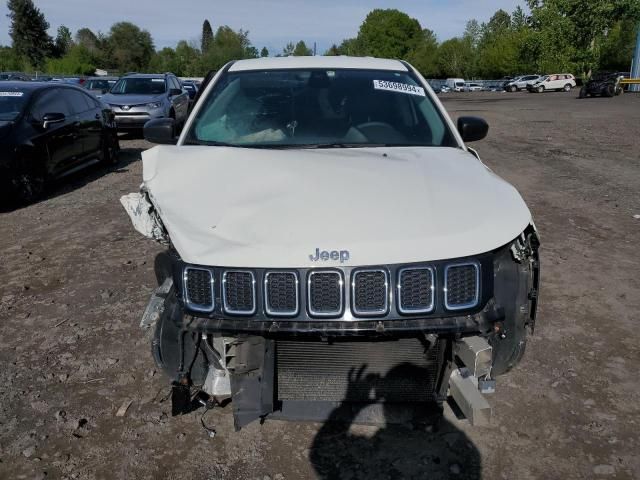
[358,9,423,58]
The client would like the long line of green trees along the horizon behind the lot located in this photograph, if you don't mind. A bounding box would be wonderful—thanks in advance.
[0,0,640,78]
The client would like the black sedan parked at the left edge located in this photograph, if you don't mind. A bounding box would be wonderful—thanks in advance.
[0,82,119,202]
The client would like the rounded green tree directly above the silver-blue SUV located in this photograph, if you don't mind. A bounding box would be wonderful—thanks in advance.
[105,22,155,72]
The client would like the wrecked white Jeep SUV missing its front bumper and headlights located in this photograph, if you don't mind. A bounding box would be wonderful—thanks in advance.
[122,57,539,428]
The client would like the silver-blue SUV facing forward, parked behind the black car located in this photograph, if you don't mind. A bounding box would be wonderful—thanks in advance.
[102,73,189,130]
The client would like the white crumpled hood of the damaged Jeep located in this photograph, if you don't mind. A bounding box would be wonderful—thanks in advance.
[143,146,531,268]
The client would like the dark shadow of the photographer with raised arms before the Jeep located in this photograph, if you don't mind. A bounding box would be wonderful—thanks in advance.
[310,363,481,480]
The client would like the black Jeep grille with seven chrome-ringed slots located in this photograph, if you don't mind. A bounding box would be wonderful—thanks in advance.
[183,256,482,321]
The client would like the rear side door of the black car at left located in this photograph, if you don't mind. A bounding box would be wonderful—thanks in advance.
[65,88,102,163]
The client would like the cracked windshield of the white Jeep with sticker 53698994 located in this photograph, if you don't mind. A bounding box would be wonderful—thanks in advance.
[186,69,457,148]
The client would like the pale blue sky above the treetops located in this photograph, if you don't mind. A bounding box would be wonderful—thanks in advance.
[0,0,524,54]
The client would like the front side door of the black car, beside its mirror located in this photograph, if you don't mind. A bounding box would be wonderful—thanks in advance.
[29,88,82,176]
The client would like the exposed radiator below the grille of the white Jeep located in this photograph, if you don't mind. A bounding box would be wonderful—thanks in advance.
[276,338,442,402]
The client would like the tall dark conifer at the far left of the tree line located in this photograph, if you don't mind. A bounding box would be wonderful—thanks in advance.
[7,0,53,67]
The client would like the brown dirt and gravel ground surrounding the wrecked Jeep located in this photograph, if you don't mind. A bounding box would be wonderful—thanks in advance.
[0,92,640,480]
